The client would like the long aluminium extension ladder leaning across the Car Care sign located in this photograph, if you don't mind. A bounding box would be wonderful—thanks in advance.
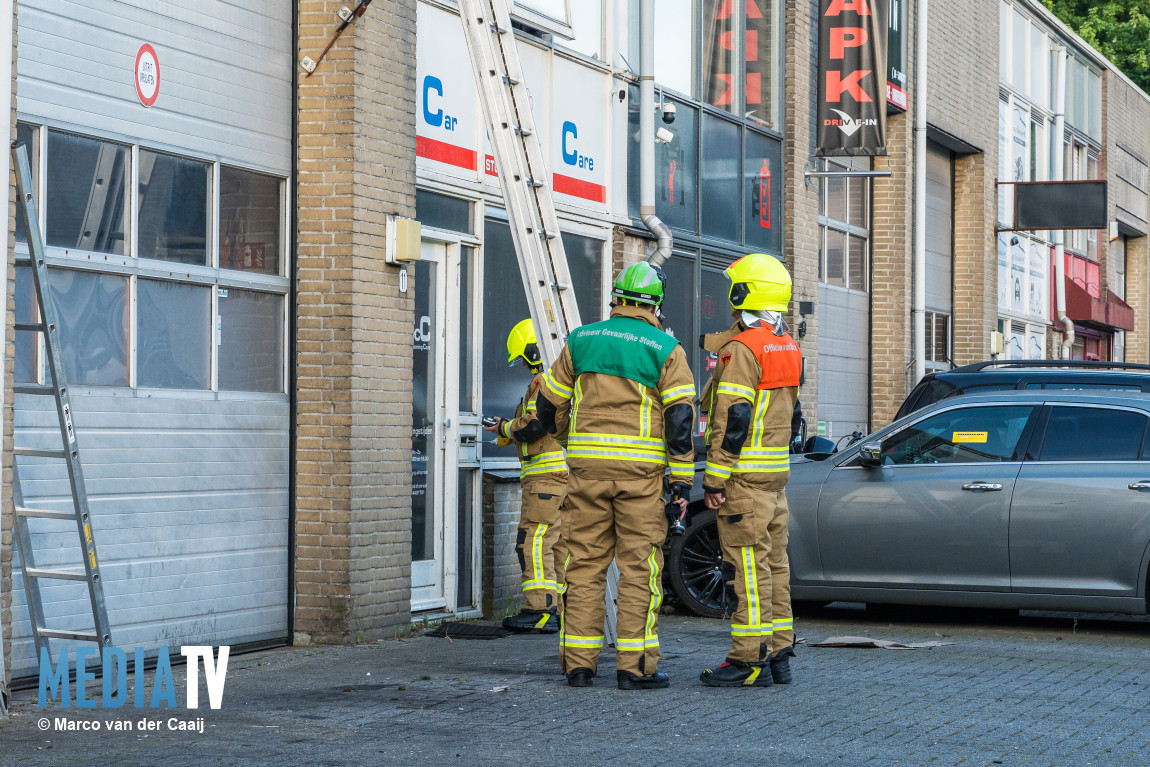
[459,0,619,644]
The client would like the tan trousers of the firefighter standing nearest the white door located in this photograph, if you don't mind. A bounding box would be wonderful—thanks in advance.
[515,473,567,613]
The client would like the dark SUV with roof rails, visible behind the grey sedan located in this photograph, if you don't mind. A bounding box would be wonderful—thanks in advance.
[895,360,1150,421]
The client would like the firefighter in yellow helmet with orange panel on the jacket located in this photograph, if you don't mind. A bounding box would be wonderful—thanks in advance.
[699,253,803,687]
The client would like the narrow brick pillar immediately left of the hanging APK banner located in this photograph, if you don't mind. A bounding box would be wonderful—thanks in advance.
[783,0,819,425]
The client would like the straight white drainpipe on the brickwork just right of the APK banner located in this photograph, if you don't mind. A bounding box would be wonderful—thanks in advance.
[913,0,929,384]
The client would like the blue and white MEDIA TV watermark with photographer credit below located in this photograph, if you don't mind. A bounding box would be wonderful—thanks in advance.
[38,646,231,712]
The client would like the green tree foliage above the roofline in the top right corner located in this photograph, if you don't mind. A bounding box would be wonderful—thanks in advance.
[1043,0,1150,91]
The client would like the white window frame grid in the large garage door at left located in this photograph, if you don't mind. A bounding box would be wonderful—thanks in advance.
[15,121,293,398]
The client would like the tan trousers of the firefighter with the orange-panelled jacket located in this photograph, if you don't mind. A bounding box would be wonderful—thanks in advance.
[718,475,795,664]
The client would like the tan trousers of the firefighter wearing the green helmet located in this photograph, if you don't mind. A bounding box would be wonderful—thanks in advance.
[559,471,667,676]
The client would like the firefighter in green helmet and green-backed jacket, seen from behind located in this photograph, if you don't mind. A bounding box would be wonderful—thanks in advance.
[538,262,695,690]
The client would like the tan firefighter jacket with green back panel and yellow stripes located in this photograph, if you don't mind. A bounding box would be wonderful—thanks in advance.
[538,306,695,484]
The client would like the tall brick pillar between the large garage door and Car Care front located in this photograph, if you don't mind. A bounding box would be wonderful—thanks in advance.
[296,0,415,642]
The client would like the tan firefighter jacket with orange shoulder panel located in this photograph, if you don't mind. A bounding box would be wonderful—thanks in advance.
[703,322,803,492]
